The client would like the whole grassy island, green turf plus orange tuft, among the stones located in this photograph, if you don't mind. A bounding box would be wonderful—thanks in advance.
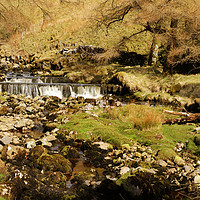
[58,105,198,157]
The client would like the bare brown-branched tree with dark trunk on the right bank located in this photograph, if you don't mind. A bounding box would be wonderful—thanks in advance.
[97,0,200,72]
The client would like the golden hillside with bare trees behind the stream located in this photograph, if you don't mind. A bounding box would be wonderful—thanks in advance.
[0,0,200,73]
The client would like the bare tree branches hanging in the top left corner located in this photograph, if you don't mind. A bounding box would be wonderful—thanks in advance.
[0,0,52,39]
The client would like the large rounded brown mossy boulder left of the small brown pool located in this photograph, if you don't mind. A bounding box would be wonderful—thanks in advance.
[36,154,72,174]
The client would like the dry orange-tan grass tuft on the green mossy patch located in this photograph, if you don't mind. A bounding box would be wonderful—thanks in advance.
[109,104,163,130]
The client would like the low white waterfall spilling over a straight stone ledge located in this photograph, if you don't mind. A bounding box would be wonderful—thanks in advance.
[0,73,102,98]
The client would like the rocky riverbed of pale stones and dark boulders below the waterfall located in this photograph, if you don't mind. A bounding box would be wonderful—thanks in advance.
[0,94,200,199]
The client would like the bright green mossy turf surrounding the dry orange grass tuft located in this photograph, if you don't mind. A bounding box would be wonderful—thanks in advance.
[58,106,195,158]
